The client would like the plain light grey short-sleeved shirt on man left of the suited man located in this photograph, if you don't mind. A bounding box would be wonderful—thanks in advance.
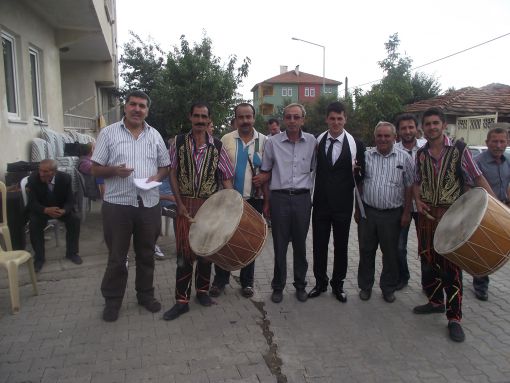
[261,132,317,190]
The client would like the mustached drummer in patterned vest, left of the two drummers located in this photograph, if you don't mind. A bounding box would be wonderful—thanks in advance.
[163,103,233,320]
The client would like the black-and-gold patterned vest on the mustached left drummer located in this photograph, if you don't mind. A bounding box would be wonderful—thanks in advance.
[175,134,222,198]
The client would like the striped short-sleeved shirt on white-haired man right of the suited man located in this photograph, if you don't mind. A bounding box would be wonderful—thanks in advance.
[362,147,413,209]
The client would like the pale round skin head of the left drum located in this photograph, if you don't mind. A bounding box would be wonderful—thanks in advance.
[189,189,244,257]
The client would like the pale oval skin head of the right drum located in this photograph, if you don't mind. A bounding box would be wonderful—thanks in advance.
[434,188,489,254]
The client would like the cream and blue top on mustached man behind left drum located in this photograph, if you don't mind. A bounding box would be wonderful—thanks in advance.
[221,129,267,198]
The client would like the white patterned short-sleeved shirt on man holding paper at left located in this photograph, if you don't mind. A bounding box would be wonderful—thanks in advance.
[92,119,170,207]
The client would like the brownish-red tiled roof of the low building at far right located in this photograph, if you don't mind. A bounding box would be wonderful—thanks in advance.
[405,83,510,116]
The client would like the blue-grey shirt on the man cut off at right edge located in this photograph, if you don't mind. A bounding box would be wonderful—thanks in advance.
[475,150,510,203]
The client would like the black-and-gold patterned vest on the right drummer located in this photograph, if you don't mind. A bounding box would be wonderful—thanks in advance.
[416,141,466,206]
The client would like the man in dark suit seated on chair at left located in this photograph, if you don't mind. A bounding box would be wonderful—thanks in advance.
[27,159,83,272]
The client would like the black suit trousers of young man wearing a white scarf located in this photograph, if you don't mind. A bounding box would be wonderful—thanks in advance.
[312,207,352,289]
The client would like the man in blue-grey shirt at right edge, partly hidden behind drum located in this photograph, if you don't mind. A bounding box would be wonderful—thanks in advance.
[473,128,510,301]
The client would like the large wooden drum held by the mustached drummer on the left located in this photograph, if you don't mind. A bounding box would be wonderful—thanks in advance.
[189,189,267,271]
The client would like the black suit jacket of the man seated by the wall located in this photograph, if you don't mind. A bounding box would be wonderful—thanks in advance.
[27,171,74,214]
